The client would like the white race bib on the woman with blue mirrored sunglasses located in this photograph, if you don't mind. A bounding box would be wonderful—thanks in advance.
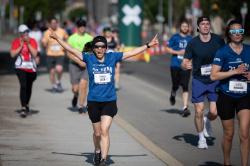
[229,79,247,93]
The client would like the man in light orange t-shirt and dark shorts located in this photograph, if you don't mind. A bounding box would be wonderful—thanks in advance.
[42,17,69,93]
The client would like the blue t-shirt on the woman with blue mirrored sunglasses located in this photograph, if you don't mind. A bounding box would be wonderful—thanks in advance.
[213,44,250,98]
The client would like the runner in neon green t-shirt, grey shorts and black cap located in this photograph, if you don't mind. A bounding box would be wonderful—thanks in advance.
[67,19,93,114]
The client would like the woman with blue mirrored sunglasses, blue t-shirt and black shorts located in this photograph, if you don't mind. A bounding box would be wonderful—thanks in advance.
[210,20,250,166]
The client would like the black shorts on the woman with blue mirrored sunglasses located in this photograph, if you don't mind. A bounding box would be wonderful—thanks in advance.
[216,92,250,120]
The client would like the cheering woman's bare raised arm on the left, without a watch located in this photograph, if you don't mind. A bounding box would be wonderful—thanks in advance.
[49,28,83,60]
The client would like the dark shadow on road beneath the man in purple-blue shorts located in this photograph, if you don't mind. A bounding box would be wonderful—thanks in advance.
[173,133,216,146]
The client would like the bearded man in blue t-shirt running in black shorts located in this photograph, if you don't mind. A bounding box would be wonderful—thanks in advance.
[166,21,192,117]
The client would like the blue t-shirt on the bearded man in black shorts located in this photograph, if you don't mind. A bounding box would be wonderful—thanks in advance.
[167,33,192,68]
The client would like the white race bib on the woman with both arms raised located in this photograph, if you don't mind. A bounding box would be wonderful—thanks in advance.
[94,71,111,85]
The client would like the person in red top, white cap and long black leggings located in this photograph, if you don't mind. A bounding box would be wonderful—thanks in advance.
[10,24,37,118]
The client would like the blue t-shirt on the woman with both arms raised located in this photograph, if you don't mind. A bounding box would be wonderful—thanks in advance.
[82,52,123,102]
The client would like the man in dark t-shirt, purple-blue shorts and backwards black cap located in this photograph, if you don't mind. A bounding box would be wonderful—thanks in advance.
[181,16,225,149]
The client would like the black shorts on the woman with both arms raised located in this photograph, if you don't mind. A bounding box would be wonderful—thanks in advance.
[87,100,118,123]
